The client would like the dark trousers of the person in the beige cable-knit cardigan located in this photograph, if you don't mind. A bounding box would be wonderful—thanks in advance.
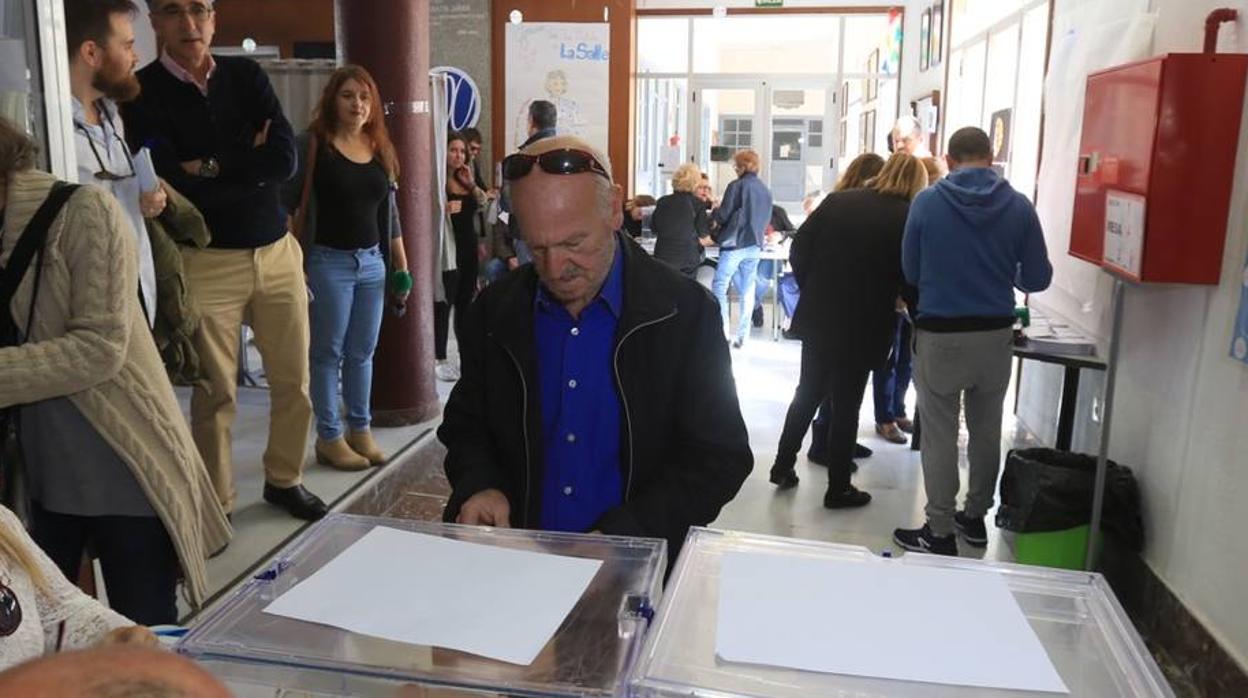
[31,503,181,626]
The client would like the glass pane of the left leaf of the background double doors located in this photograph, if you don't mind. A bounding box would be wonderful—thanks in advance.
[696,89,758,197]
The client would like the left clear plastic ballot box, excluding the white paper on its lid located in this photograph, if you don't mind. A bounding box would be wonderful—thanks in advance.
[176,514,666,698]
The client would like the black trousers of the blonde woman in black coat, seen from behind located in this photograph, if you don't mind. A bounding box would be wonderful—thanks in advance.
[775,342,871,492]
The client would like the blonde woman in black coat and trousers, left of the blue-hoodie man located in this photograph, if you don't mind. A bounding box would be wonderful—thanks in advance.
[770,154,927,508]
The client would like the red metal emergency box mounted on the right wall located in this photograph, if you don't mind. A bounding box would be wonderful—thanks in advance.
[1070,52,1248,283]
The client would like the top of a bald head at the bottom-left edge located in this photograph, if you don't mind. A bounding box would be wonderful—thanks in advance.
[0,646,230,698]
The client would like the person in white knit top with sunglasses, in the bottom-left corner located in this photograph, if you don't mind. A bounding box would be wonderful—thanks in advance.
[0,506,156,674]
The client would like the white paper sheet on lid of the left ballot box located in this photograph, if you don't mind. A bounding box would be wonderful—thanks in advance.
[265,526,603,666]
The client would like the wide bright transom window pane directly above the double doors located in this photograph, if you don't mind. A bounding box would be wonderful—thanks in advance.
[693,15,838,74]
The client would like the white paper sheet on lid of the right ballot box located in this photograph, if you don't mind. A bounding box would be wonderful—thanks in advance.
[715,552,1070,693]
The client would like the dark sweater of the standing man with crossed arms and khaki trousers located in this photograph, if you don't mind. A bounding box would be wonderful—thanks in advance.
[122,56,295,250]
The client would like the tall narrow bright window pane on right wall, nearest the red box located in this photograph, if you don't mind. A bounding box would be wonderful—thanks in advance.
[1010,2,1048,199]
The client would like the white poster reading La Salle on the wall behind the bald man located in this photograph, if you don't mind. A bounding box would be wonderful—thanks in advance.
[504,22,610,152]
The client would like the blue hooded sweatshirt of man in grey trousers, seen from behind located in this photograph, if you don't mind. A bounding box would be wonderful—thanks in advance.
[901,167,1053,328]
